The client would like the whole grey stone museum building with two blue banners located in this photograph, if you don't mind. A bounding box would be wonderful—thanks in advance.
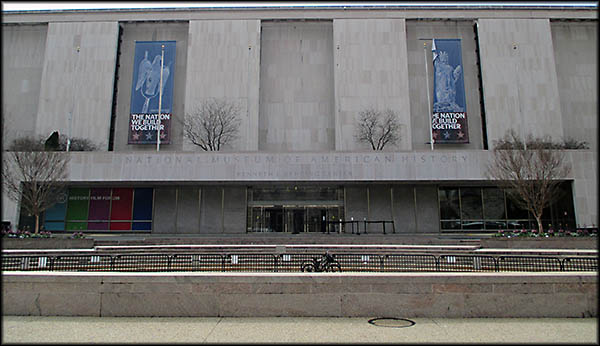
[2,5,598,234]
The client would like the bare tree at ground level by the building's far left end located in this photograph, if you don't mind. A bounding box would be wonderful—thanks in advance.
[2,140,69,233]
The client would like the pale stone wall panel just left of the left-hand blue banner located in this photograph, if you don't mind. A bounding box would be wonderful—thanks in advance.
[35,22,118,150]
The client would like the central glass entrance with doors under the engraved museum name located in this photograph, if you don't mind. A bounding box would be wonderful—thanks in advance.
[246,185,344,233]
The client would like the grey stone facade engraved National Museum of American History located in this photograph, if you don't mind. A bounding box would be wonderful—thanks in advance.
[2,7,598,233]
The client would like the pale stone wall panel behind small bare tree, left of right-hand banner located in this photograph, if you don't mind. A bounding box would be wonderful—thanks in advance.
[333,19,412,151]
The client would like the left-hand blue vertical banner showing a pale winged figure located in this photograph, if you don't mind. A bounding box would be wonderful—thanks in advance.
[127,41,175,144]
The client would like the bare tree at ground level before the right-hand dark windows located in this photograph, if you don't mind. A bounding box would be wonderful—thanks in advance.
[486,130,571,232]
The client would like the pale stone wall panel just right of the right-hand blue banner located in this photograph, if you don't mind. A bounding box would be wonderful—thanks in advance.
[478,19,563,147]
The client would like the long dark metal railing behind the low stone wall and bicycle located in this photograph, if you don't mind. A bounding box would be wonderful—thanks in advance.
[2,253,598,272]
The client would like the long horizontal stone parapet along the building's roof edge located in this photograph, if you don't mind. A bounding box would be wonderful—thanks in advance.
[2,4,598,23]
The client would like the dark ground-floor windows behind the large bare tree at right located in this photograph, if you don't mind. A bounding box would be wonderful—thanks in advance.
[438,183,576,231]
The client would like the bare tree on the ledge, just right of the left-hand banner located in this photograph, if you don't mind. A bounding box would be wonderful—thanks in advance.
[183,99,240,151]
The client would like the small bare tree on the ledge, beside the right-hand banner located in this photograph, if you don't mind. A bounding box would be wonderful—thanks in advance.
[355,108,400,150]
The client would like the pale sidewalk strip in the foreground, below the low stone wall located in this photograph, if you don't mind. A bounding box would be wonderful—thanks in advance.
[2,316,599,345]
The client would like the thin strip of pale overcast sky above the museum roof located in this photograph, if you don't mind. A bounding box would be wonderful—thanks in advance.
[2,1,598,11]
